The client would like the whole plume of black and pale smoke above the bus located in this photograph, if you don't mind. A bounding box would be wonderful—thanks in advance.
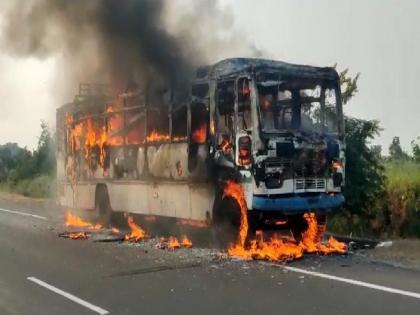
[2,0,255,96]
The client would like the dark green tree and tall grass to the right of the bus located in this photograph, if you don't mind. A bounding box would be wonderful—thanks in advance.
[328,70,420,238]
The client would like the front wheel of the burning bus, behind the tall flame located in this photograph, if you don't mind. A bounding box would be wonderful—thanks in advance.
[213,197,241,248]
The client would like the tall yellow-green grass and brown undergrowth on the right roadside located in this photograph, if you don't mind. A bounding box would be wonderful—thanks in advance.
[328,161,420,238]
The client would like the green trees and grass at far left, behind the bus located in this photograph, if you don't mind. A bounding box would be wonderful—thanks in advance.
[0,122,55,198]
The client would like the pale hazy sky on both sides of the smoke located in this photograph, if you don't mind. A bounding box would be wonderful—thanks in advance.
[0,0,420,153]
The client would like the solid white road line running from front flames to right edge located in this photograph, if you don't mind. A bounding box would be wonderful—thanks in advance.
[271,264,420,299]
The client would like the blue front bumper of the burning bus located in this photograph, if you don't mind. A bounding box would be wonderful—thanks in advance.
[252,194,344,214]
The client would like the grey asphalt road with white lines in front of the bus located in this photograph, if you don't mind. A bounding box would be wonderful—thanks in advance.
[0,201,420,315]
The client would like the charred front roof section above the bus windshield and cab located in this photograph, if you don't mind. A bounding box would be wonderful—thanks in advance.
[196,58,339,81]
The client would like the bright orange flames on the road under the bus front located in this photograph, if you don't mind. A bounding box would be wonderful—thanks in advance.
[223,181,347,261]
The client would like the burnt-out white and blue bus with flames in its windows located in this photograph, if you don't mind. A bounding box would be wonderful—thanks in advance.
[57,58,345,242]
